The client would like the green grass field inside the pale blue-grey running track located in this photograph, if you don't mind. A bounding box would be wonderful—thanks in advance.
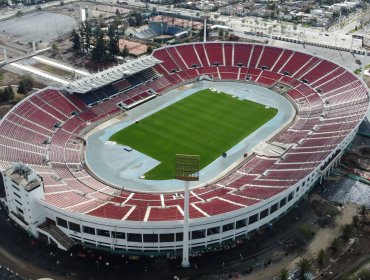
[109,89,277,180]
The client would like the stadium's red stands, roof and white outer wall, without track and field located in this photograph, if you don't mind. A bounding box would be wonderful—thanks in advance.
[0,42,369,254]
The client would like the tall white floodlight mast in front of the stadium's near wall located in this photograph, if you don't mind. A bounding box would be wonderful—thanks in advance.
[175,154,200,268]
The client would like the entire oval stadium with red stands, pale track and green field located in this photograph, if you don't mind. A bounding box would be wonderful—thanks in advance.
[0,42,369,255]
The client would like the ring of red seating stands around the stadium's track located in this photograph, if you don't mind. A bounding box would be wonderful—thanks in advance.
[0,42,368,221]
